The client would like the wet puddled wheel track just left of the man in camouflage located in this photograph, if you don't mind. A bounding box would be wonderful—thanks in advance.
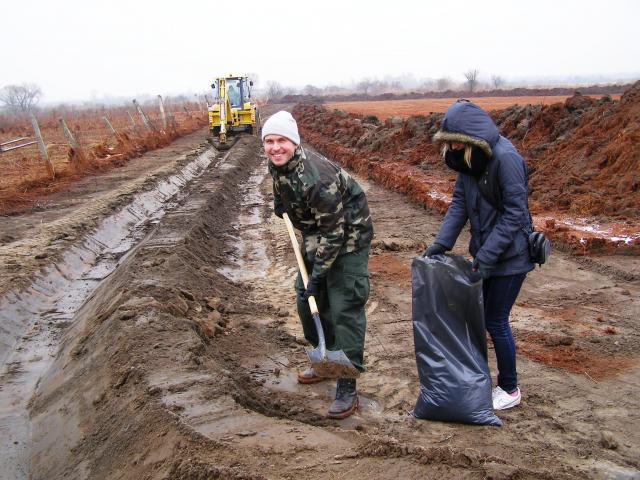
[218,159,271,282]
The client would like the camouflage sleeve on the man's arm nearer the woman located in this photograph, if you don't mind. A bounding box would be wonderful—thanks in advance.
[308,179,344,276]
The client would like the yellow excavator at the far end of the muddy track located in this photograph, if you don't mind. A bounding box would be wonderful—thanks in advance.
[209,75,260,148]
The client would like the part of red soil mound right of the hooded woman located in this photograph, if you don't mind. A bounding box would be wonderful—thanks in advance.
[496,89,640,220]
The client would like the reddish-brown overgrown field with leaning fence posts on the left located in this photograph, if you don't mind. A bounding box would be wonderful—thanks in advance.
[0,104,207,215]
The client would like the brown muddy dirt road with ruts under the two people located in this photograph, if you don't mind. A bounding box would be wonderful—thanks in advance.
[0,113,640,479]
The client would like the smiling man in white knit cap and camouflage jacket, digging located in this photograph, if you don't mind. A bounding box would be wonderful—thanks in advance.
[262,111,373,418]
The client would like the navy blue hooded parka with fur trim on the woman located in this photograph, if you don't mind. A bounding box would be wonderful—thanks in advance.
[434,101,534,277]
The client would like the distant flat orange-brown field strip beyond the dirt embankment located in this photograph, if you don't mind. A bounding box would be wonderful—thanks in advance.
[326,95,620,120]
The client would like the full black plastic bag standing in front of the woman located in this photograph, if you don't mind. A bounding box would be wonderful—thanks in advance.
[412,255,502,426]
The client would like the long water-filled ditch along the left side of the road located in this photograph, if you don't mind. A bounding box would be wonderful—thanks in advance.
[0,149,228,479]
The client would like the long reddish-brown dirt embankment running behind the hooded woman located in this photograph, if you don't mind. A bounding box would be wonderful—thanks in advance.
[294,82,640,253]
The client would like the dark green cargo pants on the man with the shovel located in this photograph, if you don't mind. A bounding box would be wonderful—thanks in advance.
[295,247,370,372]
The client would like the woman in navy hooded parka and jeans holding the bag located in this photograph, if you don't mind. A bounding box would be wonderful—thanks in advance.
[425,100,534,410]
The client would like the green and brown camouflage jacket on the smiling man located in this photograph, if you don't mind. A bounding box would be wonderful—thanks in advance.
[269,146,373,276]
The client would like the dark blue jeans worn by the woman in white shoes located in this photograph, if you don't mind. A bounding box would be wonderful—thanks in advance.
[482,273,527,393]
